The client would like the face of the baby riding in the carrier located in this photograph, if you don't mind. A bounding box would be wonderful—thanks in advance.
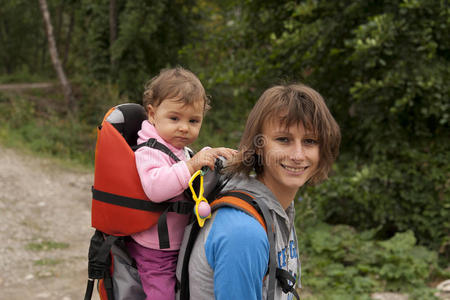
[148,99,204,149]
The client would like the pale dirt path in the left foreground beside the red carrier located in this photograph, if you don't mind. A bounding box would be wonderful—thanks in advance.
[0,146,98,300]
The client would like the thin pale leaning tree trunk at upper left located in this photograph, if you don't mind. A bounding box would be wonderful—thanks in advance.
[39,0,76,113]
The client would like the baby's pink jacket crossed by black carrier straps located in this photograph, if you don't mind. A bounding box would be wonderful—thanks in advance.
[132,121,191,250]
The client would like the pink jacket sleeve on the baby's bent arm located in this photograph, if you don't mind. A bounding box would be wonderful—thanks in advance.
[135,147,191,202]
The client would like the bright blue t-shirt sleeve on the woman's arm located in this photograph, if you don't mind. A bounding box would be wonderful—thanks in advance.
[205,207,269,300]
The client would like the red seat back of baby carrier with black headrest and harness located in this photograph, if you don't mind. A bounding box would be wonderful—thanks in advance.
[85,103,194,300]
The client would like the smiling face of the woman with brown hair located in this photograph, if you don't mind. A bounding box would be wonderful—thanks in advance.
[258,121,320,201]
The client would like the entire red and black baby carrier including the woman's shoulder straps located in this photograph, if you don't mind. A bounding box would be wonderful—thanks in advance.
[84,103,298,300]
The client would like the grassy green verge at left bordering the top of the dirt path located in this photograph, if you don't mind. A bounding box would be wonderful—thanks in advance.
[0,94,96,165]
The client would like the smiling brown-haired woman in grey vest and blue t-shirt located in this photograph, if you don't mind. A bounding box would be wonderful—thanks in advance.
[185,84,340,300]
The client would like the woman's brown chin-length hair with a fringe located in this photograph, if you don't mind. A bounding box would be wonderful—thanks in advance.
[226,84,341,184]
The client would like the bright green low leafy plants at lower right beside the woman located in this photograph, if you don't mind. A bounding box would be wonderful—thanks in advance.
[299,223,439,299]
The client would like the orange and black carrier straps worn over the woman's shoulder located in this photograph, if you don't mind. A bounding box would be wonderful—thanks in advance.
[177,190,300,300]
